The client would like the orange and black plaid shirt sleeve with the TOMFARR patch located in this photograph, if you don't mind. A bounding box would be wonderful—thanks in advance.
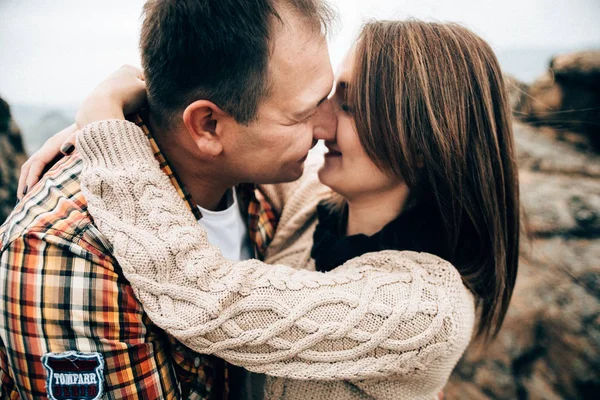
[0,232,179,399]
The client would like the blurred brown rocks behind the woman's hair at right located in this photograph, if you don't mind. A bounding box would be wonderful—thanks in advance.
[445,57,600,399]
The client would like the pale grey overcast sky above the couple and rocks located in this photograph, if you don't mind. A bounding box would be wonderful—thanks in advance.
[0,0,600,106]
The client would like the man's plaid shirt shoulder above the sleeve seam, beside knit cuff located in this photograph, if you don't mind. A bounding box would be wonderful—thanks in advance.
[0,153,112,254]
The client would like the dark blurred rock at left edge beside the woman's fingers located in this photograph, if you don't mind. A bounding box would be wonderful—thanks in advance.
[0,98,27,224]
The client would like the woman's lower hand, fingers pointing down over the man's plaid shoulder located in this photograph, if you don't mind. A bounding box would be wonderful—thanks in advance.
[17,124,77,200]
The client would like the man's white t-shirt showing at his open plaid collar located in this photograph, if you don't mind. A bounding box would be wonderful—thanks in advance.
[198,187,253,261]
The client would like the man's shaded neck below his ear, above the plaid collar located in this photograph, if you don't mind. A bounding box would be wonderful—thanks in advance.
[148,115,235,211]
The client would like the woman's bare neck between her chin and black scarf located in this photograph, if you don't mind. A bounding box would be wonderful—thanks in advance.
[346,184,409,236]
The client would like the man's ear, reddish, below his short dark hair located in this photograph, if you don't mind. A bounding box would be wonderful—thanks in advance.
[183,100,227,157]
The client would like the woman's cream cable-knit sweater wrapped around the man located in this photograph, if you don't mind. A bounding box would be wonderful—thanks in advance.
[78,120,474,399]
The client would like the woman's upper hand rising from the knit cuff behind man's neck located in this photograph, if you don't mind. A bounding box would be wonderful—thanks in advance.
[75,65,146,128]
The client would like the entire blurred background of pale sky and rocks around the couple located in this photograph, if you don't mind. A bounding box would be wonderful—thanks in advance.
[0,0,600,399]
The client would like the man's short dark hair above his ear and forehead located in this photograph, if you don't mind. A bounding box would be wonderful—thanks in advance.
[140,0,333,124]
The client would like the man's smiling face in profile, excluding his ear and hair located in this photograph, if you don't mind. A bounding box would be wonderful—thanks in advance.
[224,13,337,183]
